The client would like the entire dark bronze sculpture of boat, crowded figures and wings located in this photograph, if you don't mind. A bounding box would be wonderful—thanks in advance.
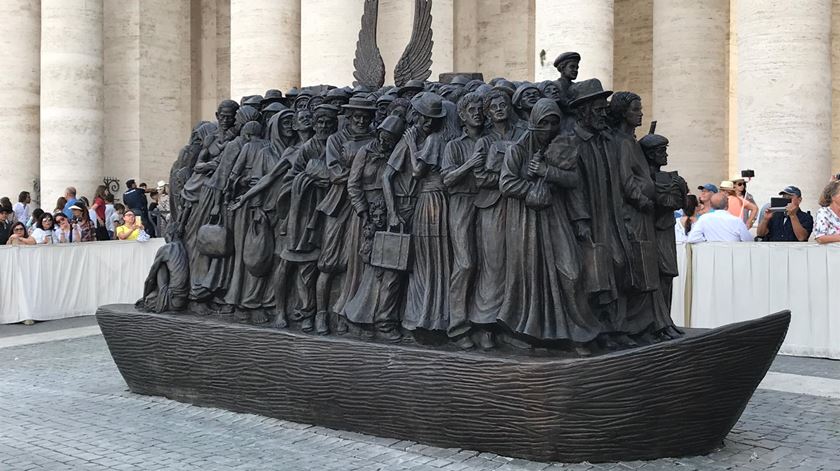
[111,5,790,461]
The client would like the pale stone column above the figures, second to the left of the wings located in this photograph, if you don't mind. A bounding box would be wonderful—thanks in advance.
[230,0,298,101]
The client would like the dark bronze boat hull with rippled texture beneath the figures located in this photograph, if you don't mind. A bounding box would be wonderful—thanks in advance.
[97,305,790,462]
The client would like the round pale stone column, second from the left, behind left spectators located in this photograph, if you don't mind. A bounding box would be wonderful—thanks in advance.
[40,0,103,209]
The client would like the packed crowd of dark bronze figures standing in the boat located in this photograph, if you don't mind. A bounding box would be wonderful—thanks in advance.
[138,53,687,354]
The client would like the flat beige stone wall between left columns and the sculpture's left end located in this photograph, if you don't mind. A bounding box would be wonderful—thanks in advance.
[104,0,193,197]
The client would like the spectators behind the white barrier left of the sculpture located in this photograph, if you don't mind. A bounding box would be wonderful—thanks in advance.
[0,180,170,245]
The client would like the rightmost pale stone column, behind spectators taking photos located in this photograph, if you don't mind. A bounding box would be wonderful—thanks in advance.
[736,0,831,212]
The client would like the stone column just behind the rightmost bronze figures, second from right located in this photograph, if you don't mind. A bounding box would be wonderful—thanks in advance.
[643,0,729,192]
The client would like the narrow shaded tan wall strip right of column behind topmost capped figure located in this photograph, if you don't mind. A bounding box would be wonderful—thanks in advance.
[612,0,656,137]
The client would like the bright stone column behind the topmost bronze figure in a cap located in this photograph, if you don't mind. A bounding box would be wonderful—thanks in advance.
[534,0,614,89]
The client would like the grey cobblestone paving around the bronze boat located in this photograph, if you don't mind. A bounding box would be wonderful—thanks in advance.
[0,336,840,471]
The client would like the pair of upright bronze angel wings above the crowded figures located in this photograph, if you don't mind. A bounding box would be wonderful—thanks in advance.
[353,0,434,89]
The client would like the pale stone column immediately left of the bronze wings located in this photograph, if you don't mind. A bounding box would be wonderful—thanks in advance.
[300,0,362,86]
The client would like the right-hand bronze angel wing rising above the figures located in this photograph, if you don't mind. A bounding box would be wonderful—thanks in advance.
[394,0,434,87]
